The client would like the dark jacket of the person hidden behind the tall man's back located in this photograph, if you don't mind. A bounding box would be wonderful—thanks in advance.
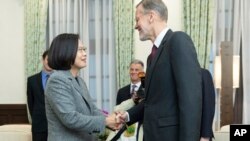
[201,69,215,138]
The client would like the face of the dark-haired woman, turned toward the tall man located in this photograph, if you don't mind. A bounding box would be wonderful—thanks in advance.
[72,40,87,69]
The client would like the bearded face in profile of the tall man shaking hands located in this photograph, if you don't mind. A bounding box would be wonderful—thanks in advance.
[135,5,151,41]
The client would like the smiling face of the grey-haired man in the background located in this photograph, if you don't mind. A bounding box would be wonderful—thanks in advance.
[129,64,143,83]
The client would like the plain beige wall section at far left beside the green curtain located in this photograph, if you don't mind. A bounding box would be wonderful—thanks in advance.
[0,0,26,104]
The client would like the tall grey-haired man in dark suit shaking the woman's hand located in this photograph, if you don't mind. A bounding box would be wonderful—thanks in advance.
[117,0,202,141]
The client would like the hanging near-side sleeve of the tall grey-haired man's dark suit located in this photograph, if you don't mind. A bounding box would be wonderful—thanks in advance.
[170,32,202,141]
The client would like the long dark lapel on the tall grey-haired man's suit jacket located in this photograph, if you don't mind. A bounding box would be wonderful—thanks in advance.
[145,29,173,97]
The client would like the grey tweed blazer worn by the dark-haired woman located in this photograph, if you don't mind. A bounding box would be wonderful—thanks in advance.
[45,71,105,141]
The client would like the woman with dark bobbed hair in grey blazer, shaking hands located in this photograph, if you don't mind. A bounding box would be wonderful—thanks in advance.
[45,33,119,141]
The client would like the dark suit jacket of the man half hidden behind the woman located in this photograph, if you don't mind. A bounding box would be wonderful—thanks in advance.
[27,72,48,133]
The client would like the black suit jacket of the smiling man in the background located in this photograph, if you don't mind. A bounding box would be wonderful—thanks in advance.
[116,84,142,105]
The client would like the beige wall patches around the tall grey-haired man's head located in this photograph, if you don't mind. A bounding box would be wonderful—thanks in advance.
[135,0,182,69]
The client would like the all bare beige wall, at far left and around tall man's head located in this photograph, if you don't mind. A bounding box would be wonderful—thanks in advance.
[0,0,181,104]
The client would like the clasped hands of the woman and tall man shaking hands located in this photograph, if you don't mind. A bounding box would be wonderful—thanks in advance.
[105,111,128,130]
